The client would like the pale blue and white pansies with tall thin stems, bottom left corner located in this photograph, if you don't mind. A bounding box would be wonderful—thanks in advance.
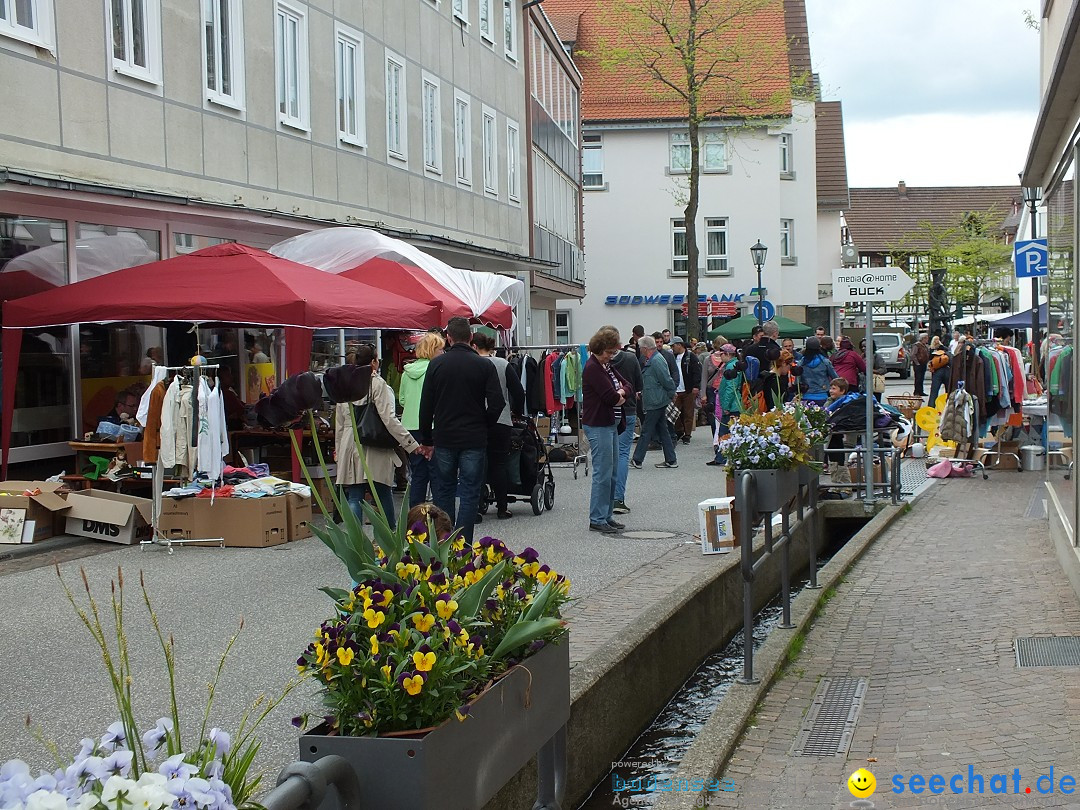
[0,568,295,810]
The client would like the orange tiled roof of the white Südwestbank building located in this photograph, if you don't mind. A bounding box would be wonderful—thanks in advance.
[543,0,810,122]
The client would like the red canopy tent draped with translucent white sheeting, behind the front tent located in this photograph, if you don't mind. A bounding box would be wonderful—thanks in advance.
[270,227,525,329]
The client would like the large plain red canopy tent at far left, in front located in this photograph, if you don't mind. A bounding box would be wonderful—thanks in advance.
[0,243,442,477]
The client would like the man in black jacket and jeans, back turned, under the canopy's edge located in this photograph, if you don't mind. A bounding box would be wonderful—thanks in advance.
[419,318,505,543]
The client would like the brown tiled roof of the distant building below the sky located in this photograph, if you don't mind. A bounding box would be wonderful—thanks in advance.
[843,180,1023,253]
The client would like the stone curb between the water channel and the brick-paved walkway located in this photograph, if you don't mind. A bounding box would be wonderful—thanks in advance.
[656,496,921,810]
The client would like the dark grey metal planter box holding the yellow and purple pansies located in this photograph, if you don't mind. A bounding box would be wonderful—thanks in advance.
[300,636,570,810]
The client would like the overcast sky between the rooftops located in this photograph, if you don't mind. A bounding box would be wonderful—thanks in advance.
[806,0,1041,187]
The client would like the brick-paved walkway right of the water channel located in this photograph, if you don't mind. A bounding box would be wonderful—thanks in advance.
[715,473,1080,808]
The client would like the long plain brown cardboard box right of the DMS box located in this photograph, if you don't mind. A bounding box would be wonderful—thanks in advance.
[158,495,288,549]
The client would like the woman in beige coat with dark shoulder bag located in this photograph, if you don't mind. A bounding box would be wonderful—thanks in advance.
[334,343,420,526]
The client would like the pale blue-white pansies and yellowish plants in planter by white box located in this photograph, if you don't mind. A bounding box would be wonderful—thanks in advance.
[719,408,813,473]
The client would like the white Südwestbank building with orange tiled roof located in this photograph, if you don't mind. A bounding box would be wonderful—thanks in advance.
[544,0,847,341]
